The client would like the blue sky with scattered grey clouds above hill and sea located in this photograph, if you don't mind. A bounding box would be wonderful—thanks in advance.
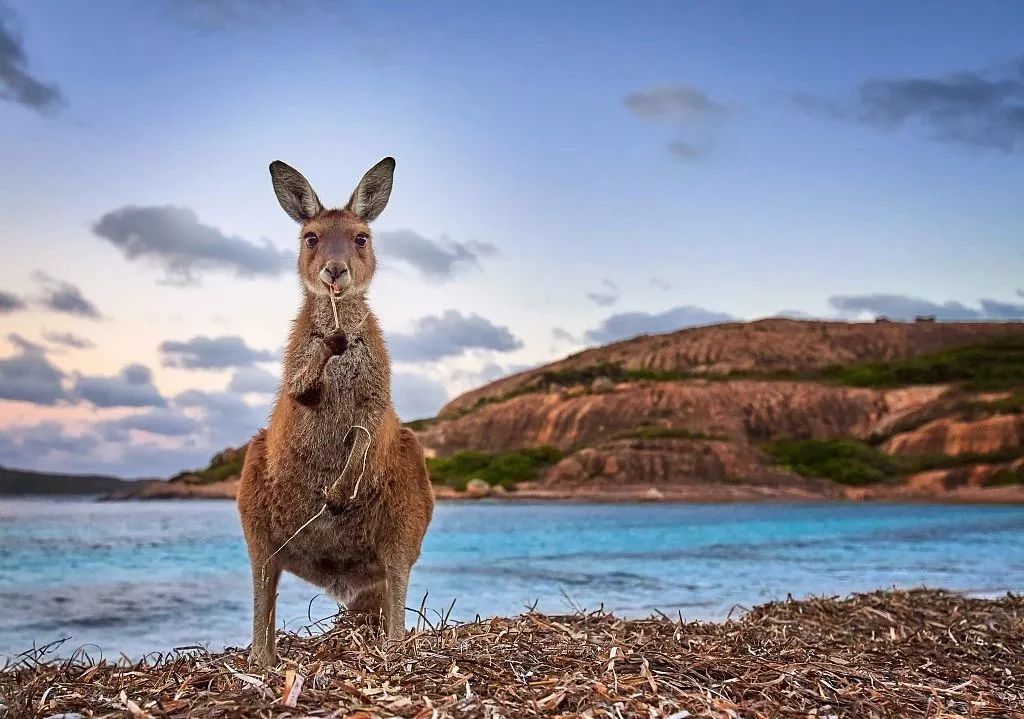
[0,0,1024,476]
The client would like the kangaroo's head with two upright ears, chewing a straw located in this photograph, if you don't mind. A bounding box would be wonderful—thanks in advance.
[270,158,394,297]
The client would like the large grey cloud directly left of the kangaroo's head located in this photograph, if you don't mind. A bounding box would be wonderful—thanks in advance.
[92,205,294,285]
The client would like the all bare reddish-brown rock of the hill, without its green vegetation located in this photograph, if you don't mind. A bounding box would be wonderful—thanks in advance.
[420,320,1024,499]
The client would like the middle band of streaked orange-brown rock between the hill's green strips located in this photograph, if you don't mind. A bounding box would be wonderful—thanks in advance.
[420,380,944,456]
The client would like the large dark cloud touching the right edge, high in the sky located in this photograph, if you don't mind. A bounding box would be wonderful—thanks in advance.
[793,56,1024,153]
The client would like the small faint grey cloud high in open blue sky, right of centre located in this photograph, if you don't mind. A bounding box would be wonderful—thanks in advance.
[623,84,732,162]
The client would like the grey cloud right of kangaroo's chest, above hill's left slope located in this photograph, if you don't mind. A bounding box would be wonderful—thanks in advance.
[388,309,522,362]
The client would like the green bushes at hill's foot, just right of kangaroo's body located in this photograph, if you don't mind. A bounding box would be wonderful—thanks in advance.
[427,447,562,492]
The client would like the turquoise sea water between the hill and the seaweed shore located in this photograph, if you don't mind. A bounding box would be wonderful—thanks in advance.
[0,499,1024,657]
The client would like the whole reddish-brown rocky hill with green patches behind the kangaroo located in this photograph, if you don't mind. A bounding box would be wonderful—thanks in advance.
[119,320,1024,502]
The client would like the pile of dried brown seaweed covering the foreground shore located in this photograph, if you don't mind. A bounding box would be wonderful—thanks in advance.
[0,590,1024,719]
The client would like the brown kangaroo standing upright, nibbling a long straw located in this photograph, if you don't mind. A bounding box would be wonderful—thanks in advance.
[238,158,433,666]
